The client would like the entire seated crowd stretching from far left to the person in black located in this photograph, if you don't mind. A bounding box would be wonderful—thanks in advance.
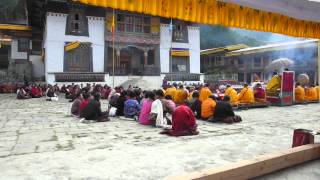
[5,83,247,136]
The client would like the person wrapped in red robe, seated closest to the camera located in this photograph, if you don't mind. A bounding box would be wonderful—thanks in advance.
[161,104,199,136]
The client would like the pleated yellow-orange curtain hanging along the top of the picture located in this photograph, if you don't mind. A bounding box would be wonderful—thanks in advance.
[74,0,320,38]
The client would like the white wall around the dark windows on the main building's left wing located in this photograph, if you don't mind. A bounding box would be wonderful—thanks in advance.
[44,12,105,83]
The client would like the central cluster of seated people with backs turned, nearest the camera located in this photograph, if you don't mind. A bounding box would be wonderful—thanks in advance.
[71,85,241,136]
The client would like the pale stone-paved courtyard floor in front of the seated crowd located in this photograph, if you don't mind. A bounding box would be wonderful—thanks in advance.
[0,94,320,180]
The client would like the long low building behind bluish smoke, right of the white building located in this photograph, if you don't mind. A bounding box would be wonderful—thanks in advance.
[201,40,318,83]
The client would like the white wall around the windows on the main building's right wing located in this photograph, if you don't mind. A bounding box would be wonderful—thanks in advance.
[160,24,200,73]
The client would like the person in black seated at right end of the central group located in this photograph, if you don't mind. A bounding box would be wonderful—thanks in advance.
[211,96,242,124]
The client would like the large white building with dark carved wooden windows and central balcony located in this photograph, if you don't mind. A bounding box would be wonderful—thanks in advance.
[0,0,200,88]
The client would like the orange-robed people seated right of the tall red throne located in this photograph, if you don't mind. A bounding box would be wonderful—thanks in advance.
[294,83,320,104]
